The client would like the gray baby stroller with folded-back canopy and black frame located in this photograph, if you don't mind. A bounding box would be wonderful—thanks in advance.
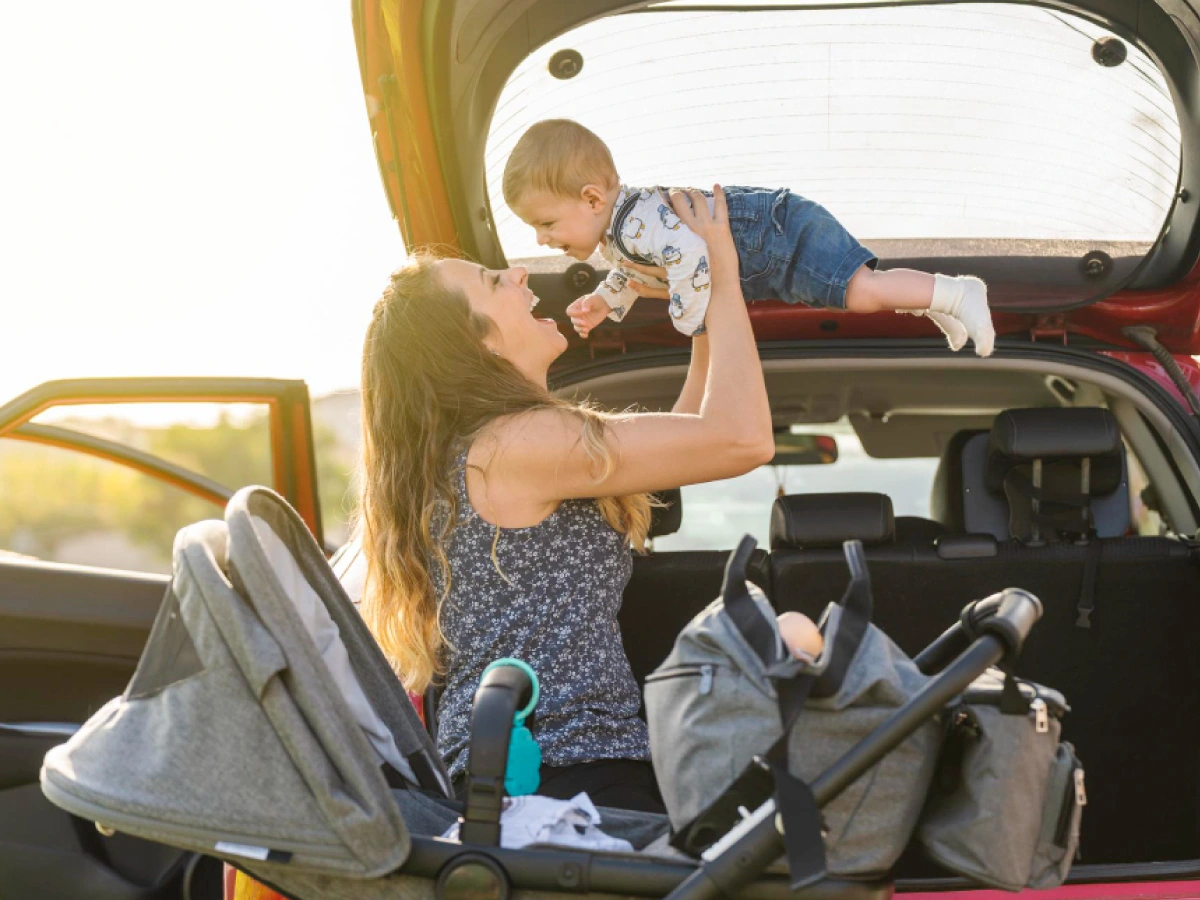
[41,487,1042,900]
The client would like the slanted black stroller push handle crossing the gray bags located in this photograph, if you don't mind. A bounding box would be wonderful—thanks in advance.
[665,588,1042,900]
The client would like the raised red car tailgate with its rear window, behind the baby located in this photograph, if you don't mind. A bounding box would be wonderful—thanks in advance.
[354,0,1200,355]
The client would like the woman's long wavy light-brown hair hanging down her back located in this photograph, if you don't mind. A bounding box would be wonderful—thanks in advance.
[356,254,650,691]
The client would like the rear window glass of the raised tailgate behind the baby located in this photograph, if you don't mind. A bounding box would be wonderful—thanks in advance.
[486,4,1180,301]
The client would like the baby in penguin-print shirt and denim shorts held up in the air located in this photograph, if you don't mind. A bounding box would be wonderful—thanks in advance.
[504,119,995,356]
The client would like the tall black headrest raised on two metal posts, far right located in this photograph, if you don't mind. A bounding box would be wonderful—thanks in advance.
[986,407,1124,494]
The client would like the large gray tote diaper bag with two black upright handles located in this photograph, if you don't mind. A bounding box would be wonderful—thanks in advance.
[646,536,943,887]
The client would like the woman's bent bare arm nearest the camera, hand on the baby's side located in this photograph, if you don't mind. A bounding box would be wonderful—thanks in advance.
[481,188,774,509]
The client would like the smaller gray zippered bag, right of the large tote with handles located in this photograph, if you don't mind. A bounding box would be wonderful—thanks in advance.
[916,670,1087,890]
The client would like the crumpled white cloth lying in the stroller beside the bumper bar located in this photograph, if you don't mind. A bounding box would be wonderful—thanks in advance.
[442,793,634,853]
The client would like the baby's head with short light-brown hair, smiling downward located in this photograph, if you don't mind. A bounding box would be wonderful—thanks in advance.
[504,119,620,259]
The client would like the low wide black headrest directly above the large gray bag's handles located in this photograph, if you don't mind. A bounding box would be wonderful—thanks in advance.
[770,493,895,550]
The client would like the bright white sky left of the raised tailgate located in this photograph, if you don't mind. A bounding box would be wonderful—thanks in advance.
[0,0,403,403]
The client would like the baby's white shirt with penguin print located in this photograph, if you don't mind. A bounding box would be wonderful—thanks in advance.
[595,185,712,336]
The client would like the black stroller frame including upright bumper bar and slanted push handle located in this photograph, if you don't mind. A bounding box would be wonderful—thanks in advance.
[246,541,1042,900]
